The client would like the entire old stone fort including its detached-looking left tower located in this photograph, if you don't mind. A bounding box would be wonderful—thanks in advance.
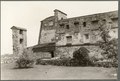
[11,9,118,58]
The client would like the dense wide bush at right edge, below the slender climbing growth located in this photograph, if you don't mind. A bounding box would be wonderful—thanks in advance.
[98,39,118,67]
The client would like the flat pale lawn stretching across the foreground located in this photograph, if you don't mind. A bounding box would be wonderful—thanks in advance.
[1,63,117,80]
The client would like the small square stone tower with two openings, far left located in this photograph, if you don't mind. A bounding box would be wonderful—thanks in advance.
[11,26,27,55]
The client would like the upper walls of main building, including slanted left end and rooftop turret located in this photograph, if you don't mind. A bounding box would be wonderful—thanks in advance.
[39,10,118,46]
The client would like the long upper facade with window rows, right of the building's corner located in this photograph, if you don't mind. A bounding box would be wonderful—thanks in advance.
[56,11,118,46]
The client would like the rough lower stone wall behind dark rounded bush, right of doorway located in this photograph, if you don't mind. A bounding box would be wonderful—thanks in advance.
[55,45,102,58]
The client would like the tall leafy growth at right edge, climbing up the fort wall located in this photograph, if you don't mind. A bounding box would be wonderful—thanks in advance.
[98,19,118,67]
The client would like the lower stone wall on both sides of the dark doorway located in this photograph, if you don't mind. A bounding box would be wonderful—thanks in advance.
[27,45,103,58]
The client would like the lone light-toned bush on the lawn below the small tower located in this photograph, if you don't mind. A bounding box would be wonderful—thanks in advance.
[16,50,35,68]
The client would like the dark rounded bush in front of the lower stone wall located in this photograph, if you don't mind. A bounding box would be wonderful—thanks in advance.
[72,47,93,66]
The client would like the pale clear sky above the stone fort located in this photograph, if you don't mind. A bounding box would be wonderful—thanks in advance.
[1,1,118,55]
